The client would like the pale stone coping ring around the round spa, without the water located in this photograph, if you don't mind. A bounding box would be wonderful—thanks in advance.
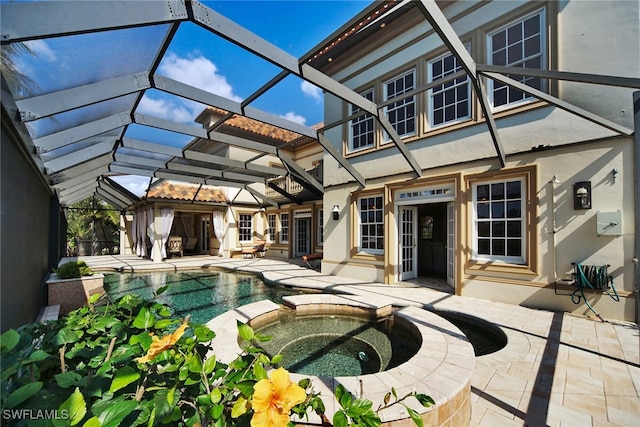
[207,294,475,426]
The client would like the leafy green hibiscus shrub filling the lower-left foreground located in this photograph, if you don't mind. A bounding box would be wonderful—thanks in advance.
[0,295,433,427]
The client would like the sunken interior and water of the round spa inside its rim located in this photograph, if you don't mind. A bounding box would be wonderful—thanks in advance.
[249,307,422,377]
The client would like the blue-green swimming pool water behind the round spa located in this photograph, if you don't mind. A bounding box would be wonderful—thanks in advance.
[104,270,302,324]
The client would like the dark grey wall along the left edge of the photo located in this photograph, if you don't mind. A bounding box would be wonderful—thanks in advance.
[0,117,57,331]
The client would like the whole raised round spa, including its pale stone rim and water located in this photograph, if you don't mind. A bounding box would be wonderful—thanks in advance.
[207,294,475,426]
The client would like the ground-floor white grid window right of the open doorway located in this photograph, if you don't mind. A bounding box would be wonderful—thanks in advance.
[473,179,526,264]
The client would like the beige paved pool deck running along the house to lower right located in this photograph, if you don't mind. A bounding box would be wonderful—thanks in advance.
[72,255,640,427]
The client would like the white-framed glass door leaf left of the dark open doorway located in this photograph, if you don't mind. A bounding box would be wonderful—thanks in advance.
[398,206,418,282]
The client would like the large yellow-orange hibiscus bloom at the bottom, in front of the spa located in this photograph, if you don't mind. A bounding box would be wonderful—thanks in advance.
[251,368,307,427]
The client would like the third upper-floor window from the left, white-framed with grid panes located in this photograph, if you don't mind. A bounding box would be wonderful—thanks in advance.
[428,47,471,127]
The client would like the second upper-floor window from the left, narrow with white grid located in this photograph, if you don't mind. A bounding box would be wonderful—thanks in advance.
[383,70,416,137]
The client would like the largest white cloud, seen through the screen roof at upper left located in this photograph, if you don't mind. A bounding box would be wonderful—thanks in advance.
[159,53,242,102]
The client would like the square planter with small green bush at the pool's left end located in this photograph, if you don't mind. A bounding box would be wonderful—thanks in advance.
[46,260,105,314]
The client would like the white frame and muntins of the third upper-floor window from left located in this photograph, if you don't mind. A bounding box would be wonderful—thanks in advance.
[427,44,472,129]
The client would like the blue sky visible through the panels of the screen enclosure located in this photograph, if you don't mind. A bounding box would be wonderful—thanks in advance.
[16,0,371,194]
